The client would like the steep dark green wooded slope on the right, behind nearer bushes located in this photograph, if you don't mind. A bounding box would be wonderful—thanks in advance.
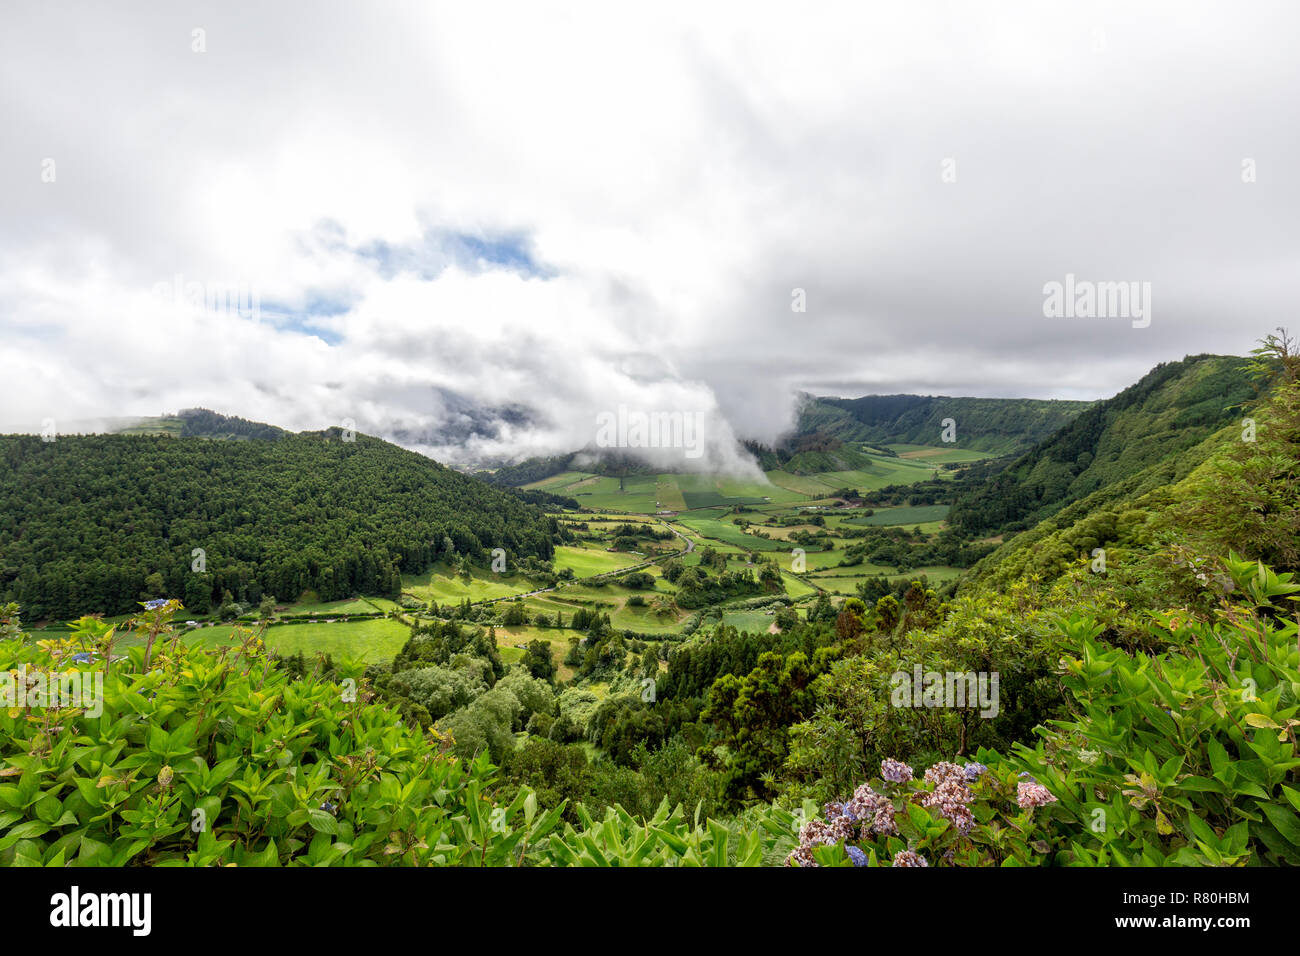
[949,355,1256,533]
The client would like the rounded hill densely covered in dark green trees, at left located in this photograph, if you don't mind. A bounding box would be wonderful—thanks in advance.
[0,431,553,620]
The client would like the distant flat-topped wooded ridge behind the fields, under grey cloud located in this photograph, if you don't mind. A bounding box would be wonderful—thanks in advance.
[797,395,1091,455]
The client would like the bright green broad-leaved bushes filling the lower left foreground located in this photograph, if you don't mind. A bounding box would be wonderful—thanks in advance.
[0,602,772,866]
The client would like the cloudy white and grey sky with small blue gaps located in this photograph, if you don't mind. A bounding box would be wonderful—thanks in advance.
[0,0,1300,468]
